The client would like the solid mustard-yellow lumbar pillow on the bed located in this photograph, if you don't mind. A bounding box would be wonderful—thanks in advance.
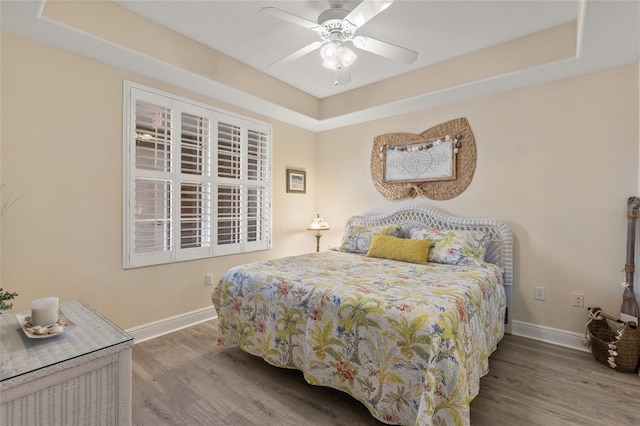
[367,234,433,265]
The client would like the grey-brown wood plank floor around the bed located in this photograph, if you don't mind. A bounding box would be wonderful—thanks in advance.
[132,320,640,426]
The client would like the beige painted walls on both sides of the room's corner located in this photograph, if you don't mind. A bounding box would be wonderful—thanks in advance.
[0,30,639,332]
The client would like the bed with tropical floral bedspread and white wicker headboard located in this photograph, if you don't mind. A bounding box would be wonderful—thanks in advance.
[212,206,513,425]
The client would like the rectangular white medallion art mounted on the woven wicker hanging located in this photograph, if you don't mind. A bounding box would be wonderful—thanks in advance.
[383,136,457,182]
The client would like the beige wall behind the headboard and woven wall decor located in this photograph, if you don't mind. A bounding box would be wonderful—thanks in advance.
[318,64,639,332]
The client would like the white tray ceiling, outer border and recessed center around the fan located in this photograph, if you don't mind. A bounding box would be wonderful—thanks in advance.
[0,0,640,131]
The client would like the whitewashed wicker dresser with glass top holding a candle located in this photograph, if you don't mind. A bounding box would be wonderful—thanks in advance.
[0,300,133,426]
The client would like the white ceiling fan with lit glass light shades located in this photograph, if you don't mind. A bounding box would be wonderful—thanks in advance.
[260,0,418,85]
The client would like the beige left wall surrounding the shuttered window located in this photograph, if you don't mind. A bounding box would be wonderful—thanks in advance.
[0,34,316,328]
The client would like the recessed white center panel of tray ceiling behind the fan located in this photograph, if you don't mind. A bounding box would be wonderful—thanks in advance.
[116,0,579,98]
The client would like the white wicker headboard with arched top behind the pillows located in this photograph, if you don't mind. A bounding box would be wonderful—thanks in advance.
[347,206,513,333]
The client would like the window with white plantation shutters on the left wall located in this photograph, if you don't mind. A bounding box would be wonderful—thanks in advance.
[123,82,271,268]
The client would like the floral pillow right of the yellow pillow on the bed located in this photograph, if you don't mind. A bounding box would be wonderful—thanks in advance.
[409,228,487,265]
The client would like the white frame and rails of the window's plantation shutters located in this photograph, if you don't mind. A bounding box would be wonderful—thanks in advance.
[122,80,273,269]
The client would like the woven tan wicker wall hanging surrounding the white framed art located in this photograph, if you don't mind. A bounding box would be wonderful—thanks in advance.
[371,117,477,200]
